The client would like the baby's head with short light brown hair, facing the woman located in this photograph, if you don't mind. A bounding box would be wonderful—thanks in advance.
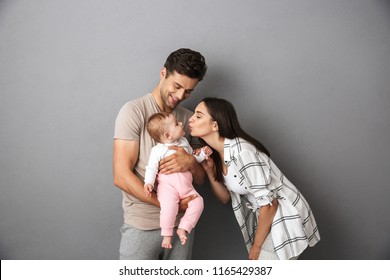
[147,112,185,143]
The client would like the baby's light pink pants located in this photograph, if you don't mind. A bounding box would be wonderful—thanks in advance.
[157,171,203,236]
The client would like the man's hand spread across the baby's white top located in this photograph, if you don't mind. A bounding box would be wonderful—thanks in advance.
[160,146,196,175]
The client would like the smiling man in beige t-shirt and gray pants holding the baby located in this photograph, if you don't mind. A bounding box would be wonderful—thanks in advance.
[113,49,207,260]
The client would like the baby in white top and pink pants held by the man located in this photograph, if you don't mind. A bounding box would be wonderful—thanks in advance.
[144,113,212,249]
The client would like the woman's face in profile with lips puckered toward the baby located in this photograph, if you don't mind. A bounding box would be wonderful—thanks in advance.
[189,102,216,138]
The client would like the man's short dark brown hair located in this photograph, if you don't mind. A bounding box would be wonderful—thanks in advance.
[164,48,207,81]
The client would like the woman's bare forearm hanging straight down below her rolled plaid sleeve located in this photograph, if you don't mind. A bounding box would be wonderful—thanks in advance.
[249,199,278,260]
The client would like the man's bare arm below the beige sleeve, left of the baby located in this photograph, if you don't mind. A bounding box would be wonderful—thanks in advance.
[113,139,160,207]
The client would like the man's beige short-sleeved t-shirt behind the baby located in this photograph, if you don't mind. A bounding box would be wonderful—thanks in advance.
[114,94,196,230]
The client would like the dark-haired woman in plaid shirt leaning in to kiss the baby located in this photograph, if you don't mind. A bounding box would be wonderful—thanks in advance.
[189,98,320,260]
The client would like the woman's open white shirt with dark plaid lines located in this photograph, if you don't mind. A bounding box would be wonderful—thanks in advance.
[224,138,320,260]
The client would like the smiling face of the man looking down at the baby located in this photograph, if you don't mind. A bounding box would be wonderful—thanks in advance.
[160,68,198,111]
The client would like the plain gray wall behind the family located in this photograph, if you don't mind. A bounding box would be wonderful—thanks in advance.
[0,0,390,259]
